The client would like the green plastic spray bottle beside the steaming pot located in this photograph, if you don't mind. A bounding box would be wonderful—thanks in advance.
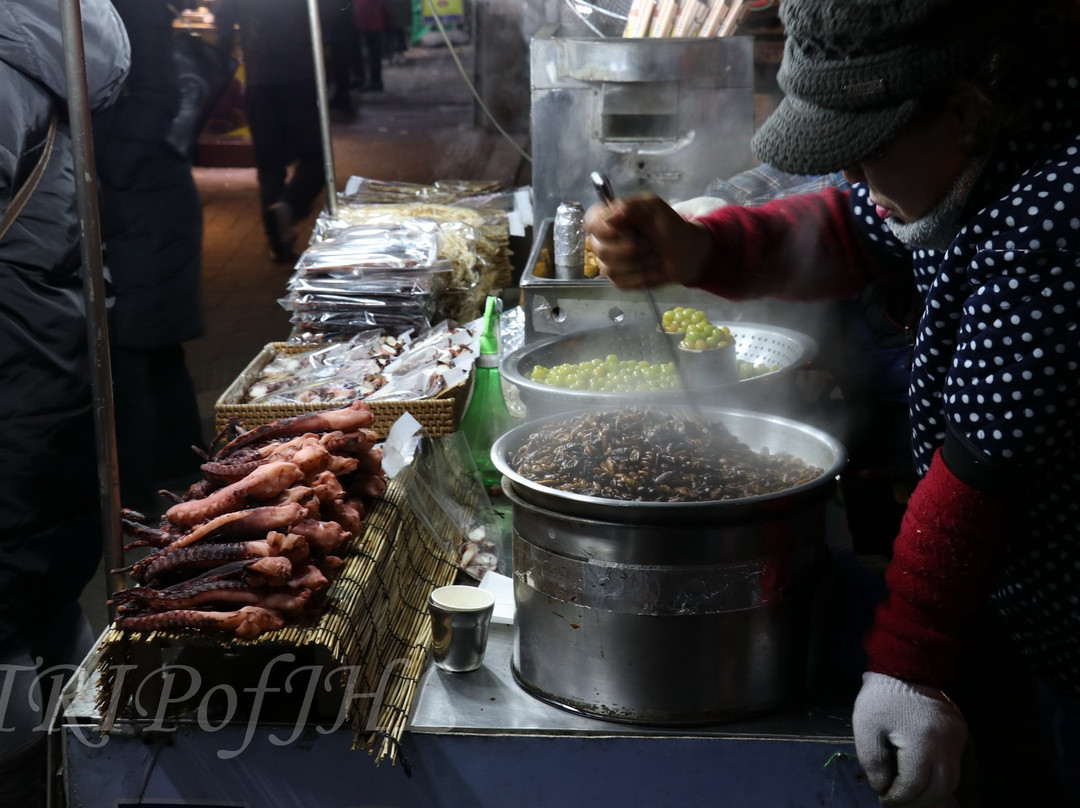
[461,296,513,489]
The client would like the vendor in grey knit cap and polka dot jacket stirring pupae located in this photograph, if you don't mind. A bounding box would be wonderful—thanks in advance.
[586,0,1080,808]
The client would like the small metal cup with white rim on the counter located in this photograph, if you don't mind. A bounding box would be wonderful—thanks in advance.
[428,585,495,673]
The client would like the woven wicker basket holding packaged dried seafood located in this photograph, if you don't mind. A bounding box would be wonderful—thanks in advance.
[214,342,469,437]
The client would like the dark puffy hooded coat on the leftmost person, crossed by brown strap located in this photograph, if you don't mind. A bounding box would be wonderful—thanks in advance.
[0,0,130,646]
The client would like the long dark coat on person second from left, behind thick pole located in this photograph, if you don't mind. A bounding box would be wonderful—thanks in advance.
[94,0,205,349]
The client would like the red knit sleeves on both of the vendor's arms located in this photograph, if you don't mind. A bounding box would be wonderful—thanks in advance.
[698,188,1005,687]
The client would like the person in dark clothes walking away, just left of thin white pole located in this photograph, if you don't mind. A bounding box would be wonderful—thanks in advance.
[214,0,324,264]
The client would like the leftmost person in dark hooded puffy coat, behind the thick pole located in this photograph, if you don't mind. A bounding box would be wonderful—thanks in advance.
[0,0,130,808]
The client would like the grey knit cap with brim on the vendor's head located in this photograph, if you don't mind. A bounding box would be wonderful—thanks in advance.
[752,0,978,174]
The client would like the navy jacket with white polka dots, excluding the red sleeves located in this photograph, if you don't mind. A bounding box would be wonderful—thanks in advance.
[851,73,1080,693]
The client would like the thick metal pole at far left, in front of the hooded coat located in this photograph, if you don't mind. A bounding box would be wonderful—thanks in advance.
[59,0,126,615]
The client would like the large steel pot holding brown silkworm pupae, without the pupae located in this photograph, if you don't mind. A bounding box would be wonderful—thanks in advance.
[491,407,845,726]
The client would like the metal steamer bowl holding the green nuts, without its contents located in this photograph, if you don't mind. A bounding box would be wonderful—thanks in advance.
[500,322,818,418]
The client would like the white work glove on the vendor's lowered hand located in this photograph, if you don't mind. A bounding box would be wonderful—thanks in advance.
[852,673,968,808]
